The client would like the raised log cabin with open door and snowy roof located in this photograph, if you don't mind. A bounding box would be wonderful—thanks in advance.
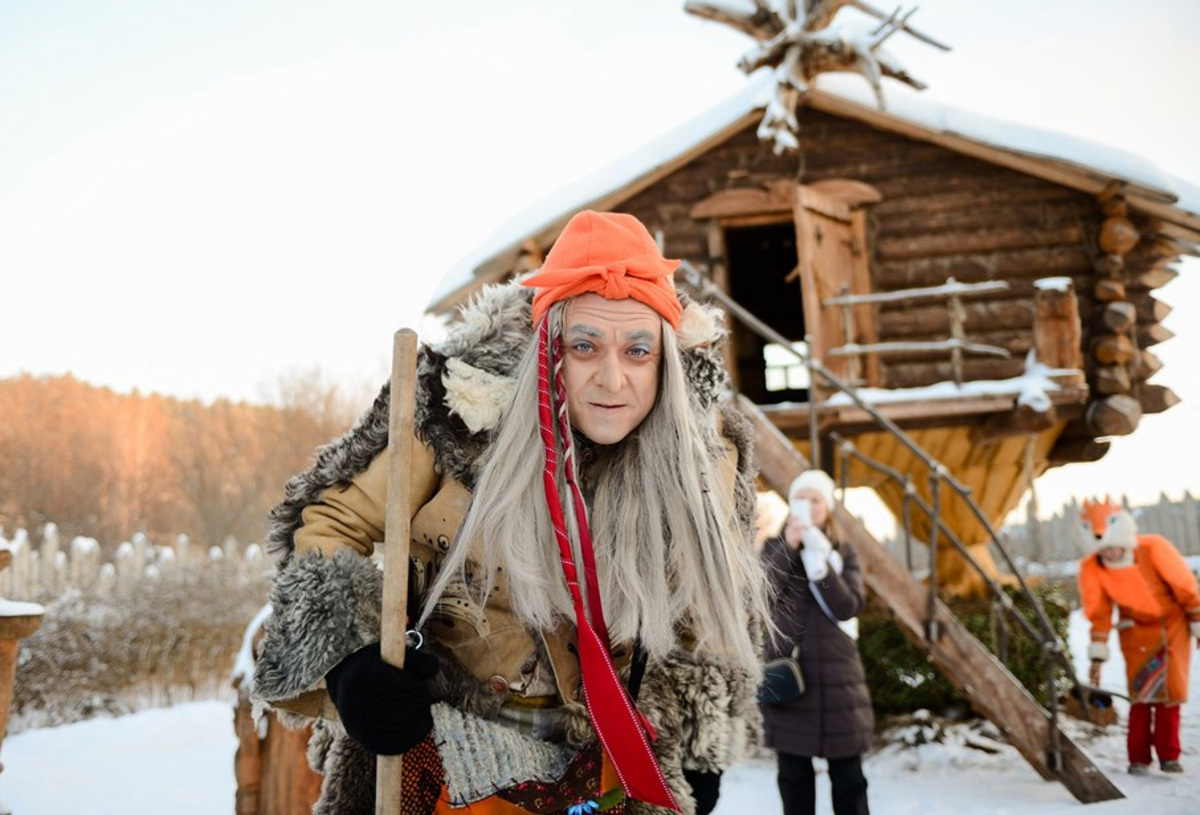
[430,76,1200,593]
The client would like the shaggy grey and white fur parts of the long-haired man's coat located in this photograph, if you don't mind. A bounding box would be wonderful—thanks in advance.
[252,277,758,815]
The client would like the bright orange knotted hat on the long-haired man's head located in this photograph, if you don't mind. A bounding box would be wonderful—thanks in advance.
[524,210,683,329]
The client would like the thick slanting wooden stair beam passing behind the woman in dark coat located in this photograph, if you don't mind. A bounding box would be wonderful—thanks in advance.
[738,397,1124,803]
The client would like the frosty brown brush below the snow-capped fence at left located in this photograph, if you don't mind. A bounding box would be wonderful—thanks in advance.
[8,558,268,732]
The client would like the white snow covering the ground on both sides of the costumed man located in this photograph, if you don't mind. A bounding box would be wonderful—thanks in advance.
[0,613,1200,815]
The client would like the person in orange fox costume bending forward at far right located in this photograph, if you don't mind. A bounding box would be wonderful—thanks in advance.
[1079,498,1200,775]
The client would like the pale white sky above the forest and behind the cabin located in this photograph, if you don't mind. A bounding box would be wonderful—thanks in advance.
[0,0,1200,516]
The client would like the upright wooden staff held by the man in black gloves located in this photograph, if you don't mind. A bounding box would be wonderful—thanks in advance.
[376,329,416,815]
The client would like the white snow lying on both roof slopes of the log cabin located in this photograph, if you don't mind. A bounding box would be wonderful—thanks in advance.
[430,71,1200,306]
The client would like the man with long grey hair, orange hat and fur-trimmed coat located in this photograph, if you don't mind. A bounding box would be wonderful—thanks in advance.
[254,211,767,814]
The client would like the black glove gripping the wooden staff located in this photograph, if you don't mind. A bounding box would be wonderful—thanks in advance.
[325,642,438,755]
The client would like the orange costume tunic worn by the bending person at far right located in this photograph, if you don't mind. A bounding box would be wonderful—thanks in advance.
[1079,535,1200,705]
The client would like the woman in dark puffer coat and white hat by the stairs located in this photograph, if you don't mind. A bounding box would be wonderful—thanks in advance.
[762,469,875,815]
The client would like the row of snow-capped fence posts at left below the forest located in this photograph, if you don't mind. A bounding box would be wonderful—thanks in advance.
[0,523,271,603]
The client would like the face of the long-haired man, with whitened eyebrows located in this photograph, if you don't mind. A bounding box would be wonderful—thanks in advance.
[563,293,662,444]
